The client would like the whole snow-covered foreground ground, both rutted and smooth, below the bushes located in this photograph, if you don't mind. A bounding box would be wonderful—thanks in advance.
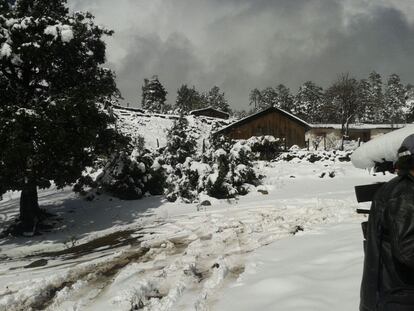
[0,161,392,311]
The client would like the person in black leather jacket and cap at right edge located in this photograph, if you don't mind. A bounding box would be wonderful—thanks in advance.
[360,135,414,311]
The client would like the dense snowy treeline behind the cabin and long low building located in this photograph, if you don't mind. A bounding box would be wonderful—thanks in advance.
[244,71,414,131]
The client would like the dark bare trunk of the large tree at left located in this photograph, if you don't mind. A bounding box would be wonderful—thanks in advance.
[20,182,40,232]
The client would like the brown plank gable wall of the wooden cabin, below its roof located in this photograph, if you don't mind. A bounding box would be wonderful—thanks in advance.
[226,111,306,148]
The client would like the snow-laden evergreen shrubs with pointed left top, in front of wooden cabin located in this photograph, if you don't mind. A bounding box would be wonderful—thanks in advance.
[158,120,259,202]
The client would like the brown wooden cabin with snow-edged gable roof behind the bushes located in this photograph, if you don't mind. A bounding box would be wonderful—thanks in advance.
[215,107,310,148]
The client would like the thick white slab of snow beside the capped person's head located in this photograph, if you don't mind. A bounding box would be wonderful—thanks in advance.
[351,124,414,168]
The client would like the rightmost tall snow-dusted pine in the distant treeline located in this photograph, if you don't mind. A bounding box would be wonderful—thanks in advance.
[385,74,406,124]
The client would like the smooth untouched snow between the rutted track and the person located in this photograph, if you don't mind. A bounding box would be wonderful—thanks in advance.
[214,222,363,311]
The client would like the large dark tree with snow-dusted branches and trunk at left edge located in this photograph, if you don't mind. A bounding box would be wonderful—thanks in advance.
[0,0,123,230]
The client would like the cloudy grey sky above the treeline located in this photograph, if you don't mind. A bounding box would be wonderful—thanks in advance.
[69,0,414,109]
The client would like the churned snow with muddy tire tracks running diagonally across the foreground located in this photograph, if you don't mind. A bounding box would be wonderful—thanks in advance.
[0,200,360,311]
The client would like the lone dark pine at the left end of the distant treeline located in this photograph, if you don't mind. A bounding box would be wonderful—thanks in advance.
[141,76,167,113]
